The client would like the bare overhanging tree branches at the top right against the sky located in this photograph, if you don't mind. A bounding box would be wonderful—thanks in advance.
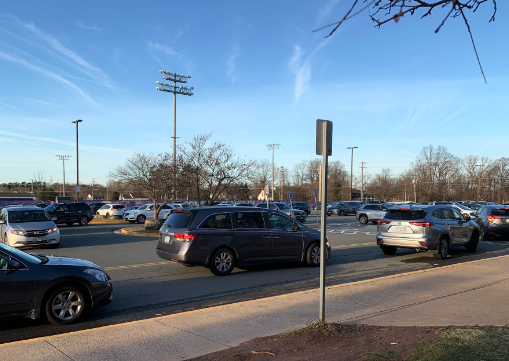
[314,0,497,82]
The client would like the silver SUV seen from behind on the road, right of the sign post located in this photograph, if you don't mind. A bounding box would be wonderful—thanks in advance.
[376,205,479,259]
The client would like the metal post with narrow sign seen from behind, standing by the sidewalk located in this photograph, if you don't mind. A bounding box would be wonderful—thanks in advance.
[316,119,332,322]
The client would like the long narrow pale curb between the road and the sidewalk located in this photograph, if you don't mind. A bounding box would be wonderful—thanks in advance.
[0,255,509,349]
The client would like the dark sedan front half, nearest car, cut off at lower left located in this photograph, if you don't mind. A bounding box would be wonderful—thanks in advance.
[0,244,112,325]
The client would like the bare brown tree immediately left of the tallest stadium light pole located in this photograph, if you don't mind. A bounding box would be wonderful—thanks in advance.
[110,152,180,220]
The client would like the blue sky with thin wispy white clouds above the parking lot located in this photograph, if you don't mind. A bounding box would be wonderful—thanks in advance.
[0,0,509,184]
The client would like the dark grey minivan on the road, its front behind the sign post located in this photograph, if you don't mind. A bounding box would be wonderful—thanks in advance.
[156,206,331,276]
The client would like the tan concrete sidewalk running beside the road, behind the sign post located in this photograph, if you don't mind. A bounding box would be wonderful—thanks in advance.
[0,256,509,361]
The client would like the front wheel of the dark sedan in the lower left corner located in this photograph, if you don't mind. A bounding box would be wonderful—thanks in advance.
[45,285,87,325]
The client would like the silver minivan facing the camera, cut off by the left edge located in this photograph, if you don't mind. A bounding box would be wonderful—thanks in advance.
[0,206,60,248]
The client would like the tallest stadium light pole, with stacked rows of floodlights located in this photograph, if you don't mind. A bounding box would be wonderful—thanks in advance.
[156,70,194,200]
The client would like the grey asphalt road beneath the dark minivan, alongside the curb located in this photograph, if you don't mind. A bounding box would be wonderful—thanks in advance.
[0,216,509,343]
